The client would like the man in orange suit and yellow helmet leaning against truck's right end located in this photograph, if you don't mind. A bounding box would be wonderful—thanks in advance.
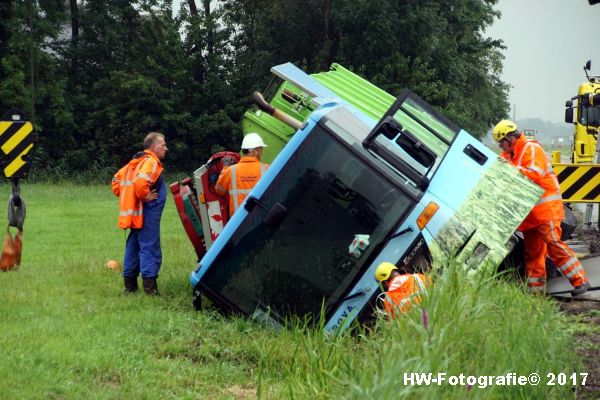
[492,120,590,296]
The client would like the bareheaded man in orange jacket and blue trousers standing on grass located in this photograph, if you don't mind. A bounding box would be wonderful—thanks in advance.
[112,132,168,295]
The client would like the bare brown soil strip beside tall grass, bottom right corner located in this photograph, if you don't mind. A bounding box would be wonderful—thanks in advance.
[560,300,600,399]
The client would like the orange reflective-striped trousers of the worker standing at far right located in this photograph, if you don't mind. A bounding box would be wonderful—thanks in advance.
[523,221,588,293]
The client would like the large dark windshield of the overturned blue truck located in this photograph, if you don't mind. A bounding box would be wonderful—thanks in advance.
[201,125,414,322]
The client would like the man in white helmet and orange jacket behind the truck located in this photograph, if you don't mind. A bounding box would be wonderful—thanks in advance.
[215,133,269,217]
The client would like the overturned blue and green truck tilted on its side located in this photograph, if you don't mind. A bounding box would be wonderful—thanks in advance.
[172,63,541,331]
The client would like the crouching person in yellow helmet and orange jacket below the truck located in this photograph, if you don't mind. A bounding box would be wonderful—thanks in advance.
[375,262,430,319]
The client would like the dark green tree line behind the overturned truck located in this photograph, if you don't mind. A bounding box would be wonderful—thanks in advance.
[0,0,509,172]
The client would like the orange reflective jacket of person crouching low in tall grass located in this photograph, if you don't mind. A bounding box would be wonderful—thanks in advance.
[383,274,429,318]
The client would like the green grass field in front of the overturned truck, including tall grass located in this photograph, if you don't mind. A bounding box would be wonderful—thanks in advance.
[0,183,583,399]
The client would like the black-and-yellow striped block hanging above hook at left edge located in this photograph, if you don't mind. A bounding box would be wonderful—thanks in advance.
[0,120,36,178]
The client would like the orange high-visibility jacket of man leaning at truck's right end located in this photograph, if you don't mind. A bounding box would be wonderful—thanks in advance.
[501,135,565,231]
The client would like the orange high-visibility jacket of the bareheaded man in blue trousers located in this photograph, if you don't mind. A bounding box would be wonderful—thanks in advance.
[112,150,163,229]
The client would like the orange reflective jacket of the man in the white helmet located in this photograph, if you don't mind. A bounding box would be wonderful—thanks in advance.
[215,157,269,216]
